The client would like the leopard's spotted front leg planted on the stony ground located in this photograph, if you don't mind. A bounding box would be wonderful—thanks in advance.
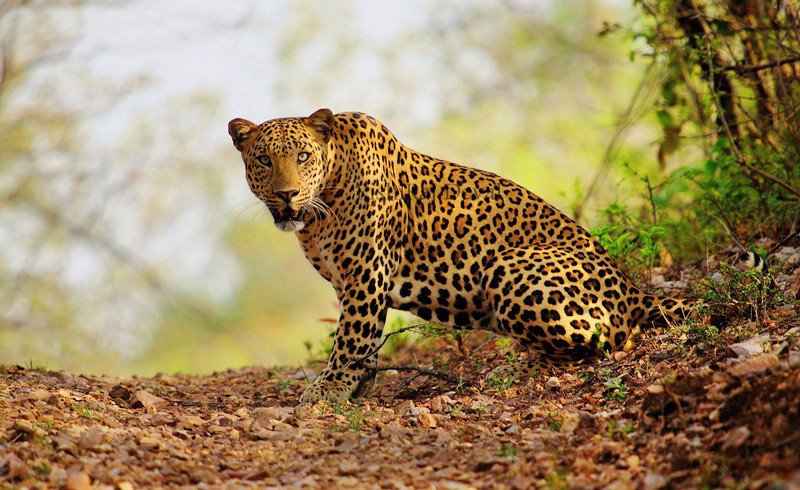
[300,275,387,403]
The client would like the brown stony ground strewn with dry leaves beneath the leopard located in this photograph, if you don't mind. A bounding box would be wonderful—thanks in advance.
[0,250,800,489]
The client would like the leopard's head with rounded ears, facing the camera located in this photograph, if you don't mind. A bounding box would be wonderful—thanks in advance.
[228,109,335,231]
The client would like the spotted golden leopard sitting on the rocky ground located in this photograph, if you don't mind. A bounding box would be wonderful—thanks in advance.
[228,109,696,403]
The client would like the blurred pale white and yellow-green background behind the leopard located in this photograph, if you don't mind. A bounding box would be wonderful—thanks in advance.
[0,0,668,375]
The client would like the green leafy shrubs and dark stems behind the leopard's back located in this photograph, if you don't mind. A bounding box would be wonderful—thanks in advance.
[595,0,800,264]
